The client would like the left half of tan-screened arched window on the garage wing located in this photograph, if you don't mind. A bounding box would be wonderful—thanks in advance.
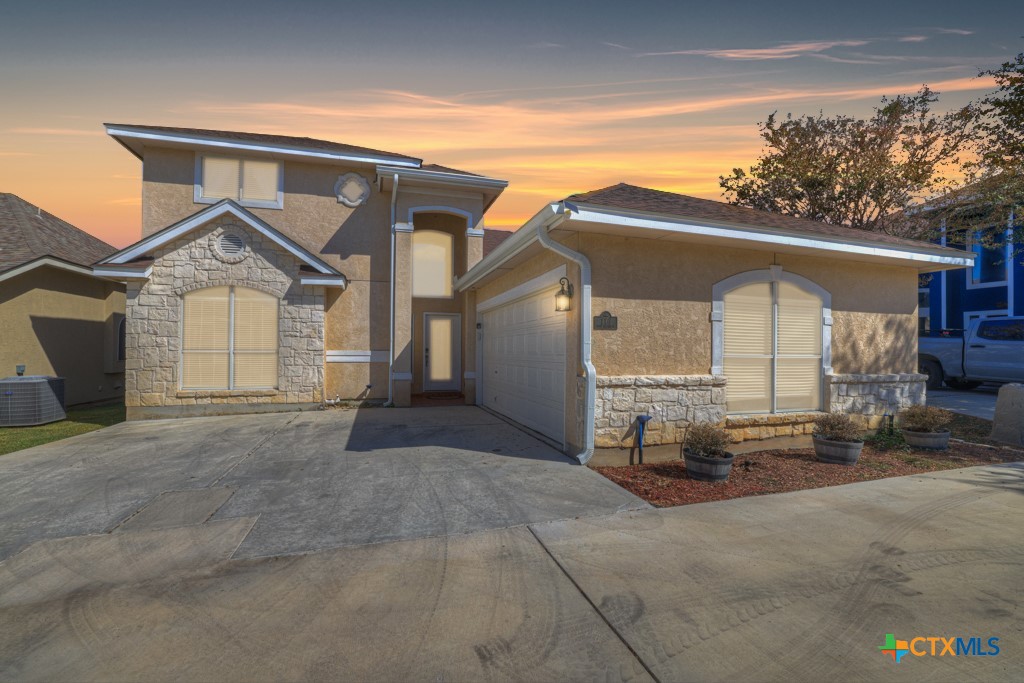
[723,283,772,413]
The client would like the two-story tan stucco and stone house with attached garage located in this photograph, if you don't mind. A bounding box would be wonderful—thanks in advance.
[96,125,973,462]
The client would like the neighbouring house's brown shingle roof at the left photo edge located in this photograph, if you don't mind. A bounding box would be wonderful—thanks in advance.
[0,193,117,271]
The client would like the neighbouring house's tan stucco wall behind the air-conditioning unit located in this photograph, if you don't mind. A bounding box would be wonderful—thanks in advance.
[0,266,125,405]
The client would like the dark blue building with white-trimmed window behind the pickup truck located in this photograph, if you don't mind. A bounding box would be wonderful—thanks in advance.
[918,228,1024,336]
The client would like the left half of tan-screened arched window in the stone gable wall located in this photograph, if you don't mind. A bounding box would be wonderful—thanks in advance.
[181,287,229,389]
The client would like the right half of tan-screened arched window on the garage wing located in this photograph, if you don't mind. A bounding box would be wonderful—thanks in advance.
[775,283,821,411]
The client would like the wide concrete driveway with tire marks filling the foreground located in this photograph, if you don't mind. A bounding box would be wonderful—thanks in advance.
[0,409,1024,682]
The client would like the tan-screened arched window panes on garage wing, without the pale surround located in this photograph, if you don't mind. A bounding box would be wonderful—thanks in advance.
[723,282,822,414]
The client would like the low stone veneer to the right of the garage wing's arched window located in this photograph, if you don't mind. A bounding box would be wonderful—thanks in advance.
[825,374,928,427]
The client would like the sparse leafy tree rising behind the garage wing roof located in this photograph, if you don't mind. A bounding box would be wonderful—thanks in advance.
[719,86,977,239]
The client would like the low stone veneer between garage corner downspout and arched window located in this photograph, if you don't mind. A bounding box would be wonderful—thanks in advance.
[594,375,725,447]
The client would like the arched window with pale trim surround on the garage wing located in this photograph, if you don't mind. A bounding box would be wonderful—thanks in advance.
[712,266,831,414]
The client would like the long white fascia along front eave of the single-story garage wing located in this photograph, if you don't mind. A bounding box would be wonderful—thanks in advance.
[568,205,974,266]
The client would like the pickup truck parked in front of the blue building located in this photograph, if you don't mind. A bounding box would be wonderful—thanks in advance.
[918,317,1024,389]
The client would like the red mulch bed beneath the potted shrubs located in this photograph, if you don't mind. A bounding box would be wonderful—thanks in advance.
[594,442,1024,508]
